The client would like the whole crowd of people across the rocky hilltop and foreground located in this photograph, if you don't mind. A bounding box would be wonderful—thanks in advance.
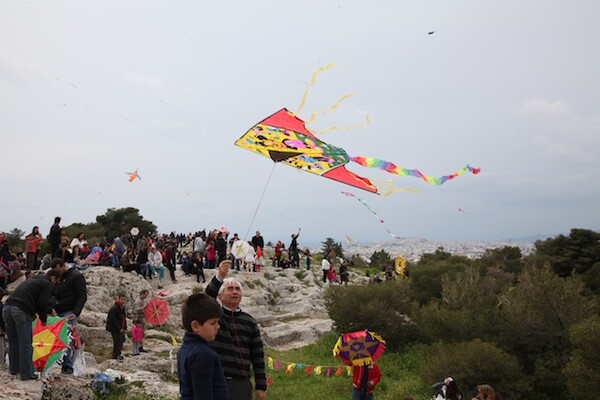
[0,217,500,400]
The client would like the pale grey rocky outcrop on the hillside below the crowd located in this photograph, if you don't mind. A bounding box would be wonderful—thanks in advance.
[0,267,332,400]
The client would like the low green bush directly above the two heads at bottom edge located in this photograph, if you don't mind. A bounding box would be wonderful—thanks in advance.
[421,340,537,400]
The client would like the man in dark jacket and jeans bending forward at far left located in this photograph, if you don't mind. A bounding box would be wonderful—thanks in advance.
[2,270,60,381]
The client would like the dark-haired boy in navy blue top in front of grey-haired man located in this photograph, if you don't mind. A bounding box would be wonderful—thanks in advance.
[177,293,229,400]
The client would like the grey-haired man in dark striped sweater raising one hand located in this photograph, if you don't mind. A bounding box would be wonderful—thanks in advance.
[206,260,267,400]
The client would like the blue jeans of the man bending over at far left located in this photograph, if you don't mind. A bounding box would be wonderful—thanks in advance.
[2,305,35,380]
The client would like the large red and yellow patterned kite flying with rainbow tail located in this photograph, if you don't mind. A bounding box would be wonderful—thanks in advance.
[235,108,480,193]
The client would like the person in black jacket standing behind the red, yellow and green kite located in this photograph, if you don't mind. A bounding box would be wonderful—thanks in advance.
[50,258,87,375]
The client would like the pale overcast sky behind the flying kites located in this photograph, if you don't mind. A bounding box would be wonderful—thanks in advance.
[0,0,600,245]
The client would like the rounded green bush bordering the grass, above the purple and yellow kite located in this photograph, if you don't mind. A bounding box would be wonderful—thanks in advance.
[325,281,417,348]
